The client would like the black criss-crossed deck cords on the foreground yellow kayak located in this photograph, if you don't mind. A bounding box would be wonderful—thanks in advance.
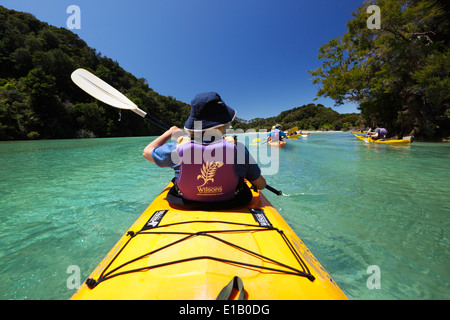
[86,211,315,289]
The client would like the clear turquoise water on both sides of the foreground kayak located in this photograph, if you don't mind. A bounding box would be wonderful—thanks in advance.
[0,133,450,299]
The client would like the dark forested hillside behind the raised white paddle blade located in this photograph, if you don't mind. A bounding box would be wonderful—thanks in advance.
[0,6,189,140]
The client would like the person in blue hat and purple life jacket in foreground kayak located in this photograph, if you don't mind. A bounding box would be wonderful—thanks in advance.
[143,92,266,209]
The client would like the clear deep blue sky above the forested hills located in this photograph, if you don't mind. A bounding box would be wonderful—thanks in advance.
[0,0,363,120]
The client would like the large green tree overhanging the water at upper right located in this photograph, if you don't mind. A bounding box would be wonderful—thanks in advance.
[310,0,450,139]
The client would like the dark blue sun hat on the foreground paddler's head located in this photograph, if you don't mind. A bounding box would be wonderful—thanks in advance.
[184,92,236,131]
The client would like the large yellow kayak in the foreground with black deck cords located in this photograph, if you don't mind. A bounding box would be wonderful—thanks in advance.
[72,183,346,300]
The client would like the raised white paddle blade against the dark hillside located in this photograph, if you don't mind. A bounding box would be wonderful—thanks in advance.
[71,68,146,117]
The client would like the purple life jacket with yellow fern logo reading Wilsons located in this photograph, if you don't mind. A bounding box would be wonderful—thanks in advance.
[176,140,239,202]
